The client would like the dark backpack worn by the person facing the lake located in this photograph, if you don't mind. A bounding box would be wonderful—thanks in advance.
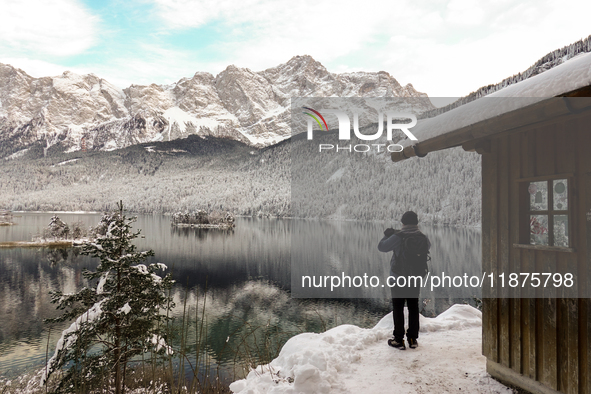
[394,231,431,278]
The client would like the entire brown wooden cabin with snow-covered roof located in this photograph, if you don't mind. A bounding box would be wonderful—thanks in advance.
[392,54,591,394]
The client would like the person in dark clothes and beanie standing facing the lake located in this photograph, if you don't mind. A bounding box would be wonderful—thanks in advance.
[378,211,431,350]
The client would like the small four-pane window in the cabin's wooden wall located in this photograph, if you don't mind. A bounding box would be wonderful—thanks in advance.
[524,179,570,248]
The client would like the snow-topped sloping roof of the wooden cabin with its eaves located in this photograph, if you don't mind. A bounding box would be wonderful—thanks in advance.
[392,53,591,162]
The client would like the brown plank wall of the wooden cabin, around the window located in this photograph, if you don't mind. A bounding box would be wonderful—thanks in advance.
[482,116,591,394]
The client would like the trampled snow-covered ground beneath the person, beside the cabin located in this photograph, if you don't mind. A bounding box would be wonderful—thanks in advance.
[230,305,513,394]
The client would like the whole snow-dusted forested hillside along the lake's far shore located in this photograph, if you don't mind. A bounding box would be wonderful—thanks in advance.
[0,136,480,225]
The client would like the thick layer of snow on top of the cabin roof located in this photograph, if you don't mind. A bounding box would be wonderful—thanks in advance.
[402,53,591,146]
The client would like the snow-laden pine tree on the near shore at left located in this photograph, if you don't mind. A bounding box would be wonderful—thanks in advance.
[41,202,173,394]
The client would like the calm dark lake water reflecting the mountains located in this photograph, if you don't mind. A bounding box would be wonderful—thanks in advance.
[0,213,481,382]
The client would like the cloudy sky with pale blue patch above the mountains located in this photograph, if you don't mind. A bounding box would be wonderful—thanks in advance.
[0,0,591,97]
